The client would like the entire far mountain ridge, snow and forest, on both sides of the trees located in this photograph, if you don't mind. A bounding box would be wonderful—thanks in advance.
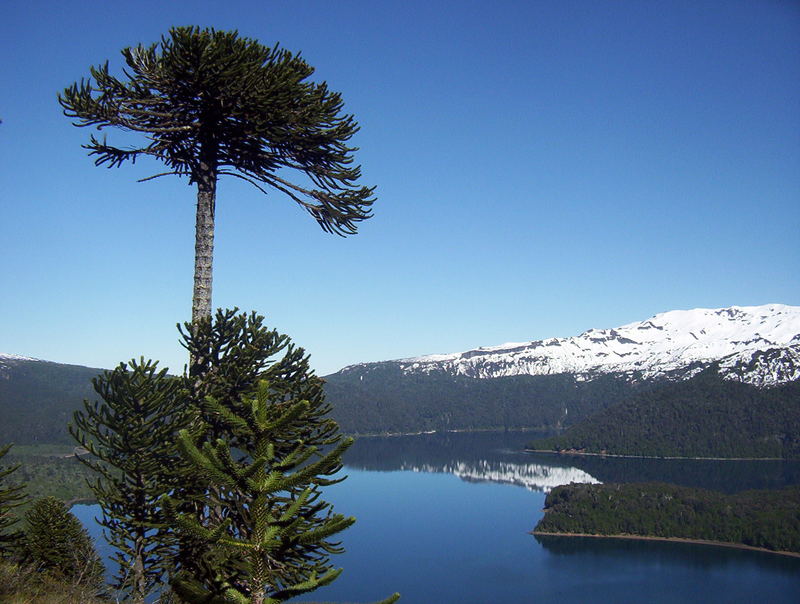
[0,304,800,444]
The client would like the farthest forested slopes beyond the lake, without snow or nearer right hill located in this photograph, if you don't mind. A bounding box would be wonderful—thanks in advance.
[0,361,652,445]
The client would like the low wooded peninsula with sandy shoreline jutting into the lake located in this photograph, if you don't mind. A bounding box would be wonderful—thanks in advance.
[534,483,800,553]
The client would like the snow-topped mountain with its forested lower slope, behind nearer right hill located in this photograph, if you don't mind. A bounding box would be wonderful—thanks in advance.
[325,304,800,433]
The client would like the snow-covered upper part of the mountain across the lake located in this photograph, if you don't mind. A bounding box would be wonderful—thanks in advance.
[343,304,800,387]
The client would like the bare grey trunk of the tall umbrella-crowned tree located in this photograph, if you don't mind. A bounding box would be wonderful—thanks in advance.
[192,166,217,324]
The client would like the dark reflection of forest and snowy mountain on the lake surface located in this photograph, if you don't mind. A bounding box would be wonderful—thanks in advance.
[344,432,800,493]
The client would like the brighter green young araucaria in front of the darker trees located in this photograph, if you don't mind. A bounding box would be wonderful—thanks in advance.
[168,380,355,602]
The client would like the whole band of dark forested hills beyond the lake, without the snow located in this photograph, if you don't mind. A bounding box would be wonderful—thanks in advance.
[6,361,800,458]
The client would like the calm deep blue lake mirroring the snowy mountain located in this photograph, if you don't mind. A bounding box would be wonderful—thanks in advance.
[73,433,800,604]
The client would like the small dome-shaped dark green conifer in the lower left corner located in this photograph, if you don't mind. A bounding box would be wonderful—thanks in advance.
[22,497,103,591]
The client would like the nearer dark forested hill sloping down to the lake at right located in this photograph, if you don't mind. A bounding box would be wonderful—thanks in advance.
[528,367,800,459]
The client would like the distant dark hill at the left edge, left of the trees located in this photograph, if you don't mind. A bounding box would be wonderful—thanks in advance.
[0,355,102,445]
